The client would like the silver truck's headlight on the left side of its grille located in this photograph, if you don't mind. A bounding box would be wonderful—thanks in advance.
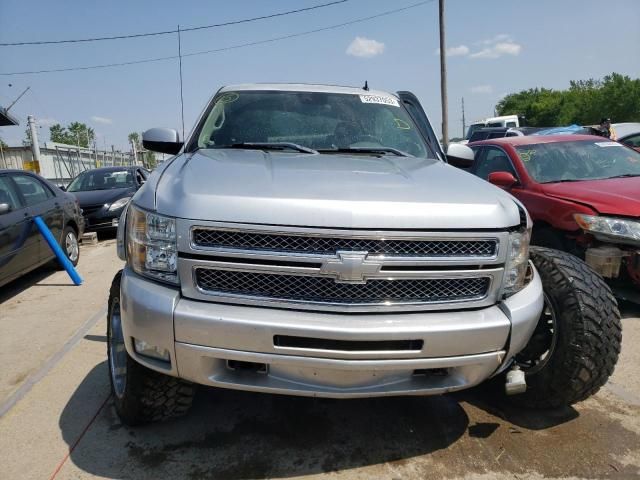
[127,205,178,284]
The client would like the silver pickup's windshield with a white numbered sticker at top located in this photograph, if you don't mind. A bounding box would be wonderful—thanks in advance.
[197,91,433,157]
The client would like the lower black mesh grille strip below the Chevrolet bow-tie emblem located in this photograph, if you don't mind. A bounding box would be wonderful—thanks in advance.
[195,268,491,305]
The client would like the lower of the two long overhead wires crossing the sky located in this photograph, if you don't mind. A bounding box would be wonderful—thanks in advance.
[0,0,434,76]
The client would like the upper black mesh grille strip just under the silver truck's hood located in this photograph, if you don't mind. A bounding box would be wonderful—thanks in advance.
[192,228,498,257]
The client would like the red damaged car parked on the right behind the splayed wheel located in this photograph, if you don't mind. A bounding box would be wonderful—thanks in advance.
[469,135,640,300]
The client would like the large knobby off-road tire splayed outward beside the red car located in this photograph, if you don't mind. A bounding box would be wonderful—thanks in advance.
[510,247,622,408]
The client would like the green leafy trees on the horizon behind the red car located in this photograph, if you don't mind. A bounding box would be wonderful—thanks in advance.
[496,73,640,127]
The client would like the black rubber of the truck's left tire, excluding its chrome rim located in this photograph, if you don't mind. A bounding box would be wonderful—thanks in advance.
[107,270,196,426]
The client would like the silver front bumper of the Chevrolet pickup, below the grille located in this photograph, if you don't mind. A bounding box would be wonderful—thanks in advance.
[121,268,543,398]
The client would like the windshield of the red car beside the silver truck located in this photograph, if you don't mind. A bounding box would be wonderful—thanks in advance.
[515,140,640,183]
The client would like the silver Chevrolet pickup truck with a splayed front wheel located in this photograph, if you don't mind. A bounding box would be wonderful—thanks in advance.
[107,84,621,424]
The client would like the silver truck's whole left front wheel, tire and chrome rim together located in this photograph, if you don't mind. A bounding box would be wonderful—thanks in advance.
[107,270,196,426]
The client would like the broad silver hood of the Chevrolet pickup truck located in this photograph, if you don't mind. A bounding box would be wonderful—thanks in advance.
[140,149,519,229]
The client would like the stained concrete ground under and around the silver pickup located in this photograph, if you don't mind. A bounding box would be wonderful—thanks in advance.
[0,240,640,479]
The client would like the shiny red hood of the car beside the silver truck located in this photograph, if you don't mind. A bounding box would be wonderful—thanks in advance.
[542,177,640,217]
